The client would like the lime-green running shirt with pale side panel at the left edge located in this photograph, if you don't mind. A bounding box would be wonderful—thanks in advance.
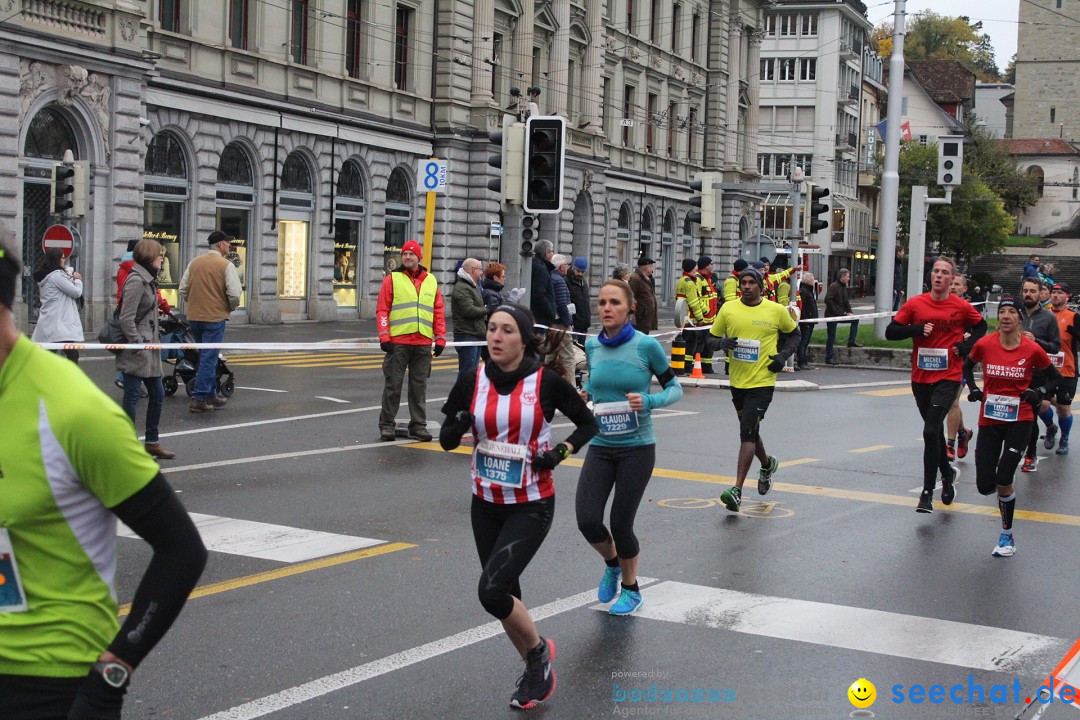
[0,336,159,678]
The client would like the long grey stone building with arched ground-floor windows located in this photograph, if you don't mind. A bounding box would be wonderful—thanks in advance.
[6,0,761,328]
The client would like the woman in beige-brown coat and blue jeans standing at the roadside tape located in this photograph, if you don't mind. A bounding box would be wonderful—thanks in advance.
[117,240,176,460]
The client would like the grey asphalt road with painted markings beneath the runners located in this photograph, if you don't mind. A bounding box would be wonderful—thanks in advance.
[69,326,1080,720]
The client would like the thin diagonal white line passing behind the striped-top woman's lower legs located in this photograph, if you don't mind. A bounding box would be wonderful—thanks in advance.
[202,576,656,720]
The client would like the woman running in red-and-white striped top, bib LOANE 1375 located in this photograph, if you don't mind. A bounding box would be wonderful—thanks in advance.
[438,305,597,709]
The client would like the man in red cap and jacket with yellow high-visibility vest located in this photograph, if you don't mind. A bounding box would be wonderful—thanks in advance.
[375,240,446,443]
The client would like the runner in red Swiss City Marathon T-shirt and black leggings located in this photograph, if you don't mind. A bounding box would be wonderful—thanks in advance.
[963,296,1062,557]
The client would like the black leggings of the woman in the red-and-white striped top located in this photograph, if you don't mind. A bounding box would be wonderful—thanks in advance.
[471,495,555,620]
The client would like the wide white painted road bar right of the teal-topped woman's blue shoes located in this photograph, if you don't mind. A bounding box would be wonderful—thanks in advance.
[593,581,1070,673]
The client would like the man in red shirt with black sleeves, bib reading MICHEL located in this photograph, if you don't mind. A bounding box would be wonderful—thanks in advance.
[885,257,986,513]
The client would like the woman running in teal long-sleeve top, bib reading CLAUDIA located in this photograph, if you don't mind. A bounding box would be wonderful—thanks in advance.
[576,280,683,615]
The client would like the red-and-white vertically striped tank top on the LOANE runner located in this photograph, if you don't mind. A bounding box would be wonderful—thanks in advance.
[471,365,555,505]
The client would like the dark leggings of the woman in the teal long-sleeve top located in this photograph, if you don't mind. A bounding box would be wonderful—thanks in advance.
[576,445,657,560]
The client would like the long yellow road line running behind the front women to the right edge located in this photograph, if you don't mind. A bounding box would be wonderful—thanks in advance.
[399,443,1080,527]
